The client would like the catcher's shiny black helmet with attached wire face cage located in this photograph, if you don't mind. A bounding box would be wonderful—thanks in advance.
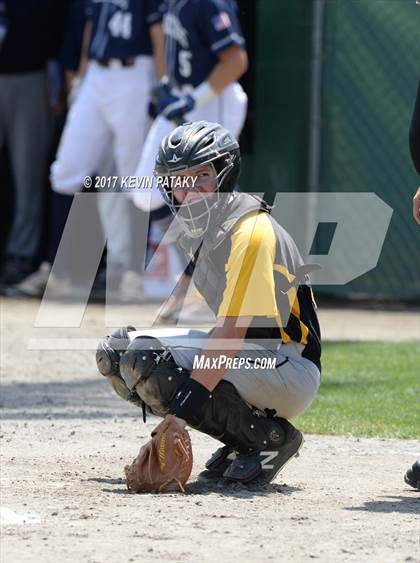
[155,121,241,237]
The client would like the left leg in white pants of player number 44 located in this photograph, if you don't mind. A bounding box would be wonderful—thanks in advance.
[51,67,111,194]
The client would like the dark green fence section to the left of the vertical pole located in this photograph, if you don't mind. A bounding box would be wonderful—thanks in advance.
[239,0,312,200]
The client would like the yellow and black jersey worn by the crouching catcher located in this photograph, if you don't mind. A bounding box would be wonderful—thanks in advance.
[198,210,321,368]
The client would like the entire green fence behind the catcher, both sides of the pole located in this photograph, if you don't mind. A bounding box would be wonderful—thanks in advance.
[243,0,420,299]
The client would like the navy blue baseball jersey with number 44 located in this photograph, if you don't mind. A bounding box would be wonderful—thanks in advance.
[86,0,161,60]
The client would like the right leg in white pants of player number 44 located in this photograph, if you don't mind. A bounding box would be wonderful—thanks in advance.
[100,57,154,304]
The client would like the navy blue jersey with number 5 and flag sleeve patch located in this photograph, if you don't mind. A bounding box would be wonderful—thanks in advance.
[160,0,245,87]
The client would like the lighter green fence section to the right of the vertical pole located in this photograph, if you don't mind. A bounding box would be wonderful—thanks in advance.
[319,0,420,298]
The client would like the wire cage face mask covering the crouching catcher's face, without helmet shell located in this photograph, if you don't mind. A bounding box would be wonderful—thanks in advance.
[156,158,233,238]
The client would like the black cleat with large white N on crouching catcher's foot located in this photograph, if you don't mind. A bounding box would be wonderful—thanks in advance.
[223,419,303,485]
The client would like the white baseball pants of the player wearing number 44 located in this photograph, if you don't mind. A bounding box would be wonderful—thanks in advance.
[51,56,156,194]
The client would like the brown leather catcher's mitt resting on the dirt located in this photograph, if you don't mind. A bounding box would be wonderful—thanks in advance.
[124,415,193,493]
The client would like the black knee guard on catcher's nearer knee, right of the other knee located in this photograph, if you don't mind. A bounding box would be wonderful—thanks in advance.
[120,336,189,415]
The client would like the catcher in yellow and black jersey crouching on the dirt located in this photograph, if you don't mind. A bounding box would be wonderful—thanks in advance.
[97,122,321,490]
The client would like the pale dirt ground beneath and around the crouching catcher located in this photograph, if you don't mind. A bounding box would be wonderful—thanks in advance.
[0,300,420,563]
